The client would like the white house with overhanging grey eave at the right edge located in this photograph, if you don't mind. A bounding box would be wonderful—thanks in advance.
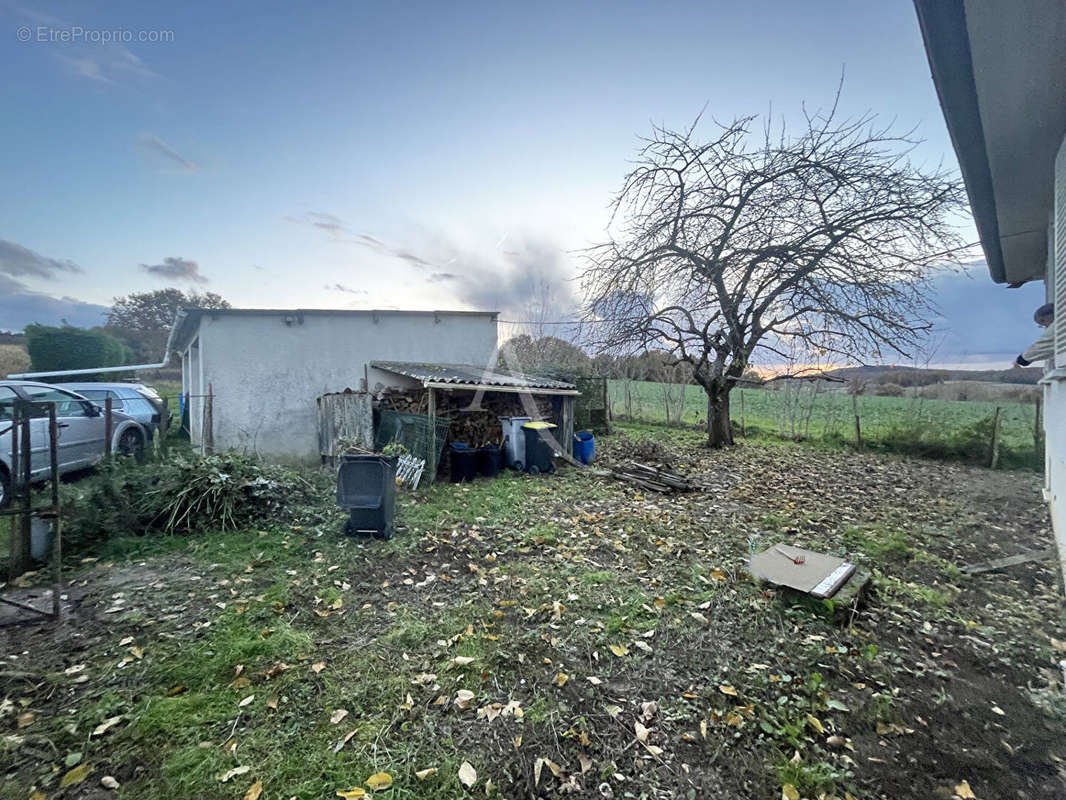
[915,0,1066,584]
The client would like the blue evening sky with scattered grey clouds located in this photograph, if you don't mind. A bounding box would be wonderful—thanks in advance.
[0,0,1043,366]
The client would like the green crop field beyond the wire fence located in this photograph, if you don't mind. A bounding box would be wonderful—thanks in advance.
[609,381,1043,469]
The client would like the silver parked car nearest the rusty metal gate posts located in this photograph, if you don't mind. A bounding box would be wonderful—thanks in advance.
[0,381,148,507]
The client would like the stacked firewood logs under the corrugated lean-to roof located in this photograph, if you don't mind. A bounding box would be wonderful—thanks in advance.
[377,387,558,447]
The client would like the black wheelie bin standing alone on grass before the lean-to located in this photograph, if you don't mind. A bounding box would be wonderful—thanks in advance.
[337,453,397,539]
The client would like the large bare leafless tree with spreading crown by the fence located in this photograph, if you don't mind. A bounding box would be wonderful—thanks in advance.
[582,97,965,447]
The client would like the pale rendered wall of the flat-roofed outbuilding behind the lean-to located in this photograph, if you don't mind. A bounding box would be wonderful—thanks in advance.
[183,311,497,460]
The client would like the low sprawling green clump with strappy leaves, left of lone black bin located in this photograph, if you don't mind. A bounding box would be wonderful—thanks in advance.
[62,453,324,549]
